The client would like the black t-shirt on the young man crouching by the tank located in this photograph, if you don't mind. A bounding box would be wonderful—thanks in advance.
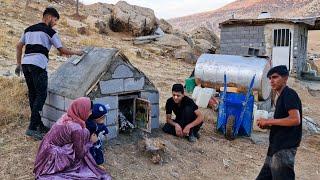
[166,96,198,119]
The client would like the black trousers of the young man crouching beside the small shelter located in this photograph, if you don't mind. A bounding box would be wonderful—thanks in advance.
[162,106,203,136]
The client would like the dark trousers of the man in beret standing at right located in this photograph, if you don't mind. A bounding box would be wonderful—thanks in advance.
[256,148,297,180]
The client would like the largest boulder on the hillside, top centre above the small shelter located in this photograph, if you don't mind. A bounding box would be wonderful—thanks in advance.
[110,1,157,36]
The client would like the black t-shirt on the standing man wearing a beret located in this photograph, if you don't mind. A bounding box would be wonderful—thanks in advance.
[268,86,302,156]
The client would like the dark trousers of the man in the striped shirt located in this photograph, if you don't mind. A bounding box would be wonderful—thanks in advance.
[22,64,48,130]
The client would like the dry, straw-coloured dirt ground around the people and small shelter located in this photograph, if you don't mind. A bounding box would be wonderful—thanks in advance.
[0,0,320,180]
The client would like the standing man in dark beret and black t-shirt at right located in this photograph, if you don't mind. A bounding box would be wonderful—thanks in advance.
[257,65,302,180]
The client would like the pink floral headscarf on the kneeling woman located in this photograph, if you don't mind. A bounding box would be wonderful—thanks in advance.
[58,97,91,128]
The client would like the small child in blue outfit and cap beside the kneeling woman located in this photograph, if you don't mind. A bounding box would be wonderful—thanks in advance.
[86,104,109,165]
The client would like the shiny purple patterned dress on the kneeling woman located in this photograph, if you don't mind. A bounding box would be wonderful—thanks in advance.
[33,121,111,180]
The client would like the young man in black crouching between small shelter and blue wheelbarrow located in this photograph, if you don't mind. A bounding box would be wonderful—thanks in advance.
[162,84,203,142]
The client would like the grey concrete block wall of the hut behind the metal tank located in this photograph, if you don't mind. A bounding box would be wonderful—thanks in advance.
[220,26,265,55]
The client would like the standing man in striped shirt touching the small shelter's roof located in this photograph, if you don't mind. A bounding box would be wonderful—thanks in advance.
[15,7,82,140]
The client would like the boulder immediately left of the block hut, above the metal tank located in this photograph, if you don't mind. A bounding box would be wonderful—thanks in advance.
[190,27,219,47]
